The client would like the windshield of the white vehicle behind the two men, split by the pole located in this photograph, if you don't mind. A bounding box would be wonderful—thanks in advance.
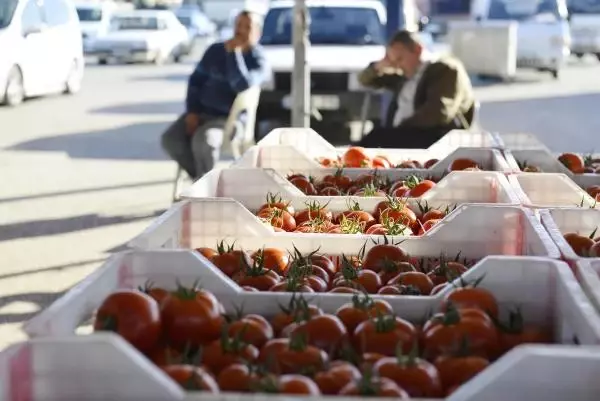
[261,7,385,45]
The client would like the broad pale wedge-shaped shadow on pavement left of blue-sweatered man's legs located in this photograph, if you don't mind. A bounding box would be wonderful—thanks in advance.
[7,121,172,160]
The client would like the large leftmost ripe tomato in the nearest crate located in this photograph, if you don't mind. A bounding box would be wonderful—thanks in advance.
[94,290,161,352]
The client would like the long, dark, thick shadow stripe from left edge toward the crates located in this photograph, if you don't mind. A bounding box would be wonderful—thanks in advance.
[0,210,164,241]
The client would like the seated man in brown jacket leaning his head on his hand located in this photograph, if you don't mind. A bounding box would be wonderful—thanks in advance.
[359,31,474,148]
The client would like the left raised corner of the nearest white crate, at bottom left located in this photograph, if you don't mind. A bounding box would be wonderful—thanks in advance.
[0,333,185,401]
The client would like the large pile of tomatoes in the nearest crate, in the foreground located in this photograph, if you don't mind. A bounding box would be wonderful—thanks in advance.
[94,280,551,399]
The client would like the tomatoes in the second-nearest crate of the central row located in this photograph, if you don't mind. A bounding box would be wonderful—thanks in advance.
[197,238,475,295]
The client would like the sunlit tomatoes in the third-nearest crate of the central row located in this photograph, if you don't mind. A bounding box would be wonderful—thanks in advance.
[256,194,456,236]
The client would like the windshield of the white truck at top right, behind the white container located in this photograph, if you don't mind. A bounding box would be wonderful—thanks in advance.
[488,0,566,21]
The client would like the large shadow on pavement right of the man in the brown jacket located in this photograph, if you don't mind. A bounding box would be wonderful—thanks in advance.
[480,93,600,153]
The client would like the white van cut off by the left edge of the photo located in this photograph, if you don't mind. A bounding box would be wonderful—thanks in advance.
[0,0,84,106]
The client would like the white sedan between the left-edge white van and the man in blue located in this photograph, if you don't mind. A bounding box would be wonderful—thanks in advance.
[94,10,190,64]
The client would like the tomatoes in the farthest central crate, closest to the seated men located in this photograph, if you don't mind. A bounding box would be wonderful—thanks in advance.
[318,146,481,171]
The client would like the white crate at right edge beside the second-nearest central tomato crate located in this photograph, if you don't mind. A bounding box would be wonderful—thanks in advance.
[540,208,600,261]
